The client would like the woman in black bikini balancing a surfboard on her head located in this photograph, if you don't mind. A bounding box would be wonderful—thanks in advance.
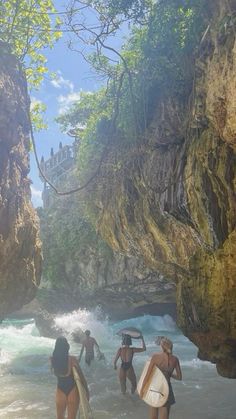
[114,335,146,394]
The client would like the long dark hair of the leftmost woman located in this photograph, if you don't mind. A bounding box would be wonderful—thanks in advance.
[52,336,70,375]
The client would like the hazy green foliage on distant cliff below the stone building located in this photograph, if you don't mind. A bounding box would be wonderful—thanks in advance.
[38,186,111,288]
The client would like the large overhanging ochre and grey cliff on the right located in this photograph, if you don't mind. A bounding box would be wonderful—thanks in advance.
[80,1,236,378]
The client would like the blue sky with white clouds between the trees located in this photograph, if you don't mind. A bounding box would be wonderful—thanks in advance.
[29,0,127,207]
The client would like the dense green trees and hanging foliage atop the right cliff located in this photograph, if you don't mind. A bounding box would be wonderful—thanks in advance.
[58,0,207,179]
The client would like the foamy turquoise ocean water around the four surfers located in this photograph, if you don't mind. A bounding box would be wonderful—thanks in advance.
[0,310,236,419]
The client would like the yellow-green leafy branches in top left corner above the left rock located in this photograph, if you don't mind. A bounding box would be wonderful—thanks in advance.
[0,0,61,88]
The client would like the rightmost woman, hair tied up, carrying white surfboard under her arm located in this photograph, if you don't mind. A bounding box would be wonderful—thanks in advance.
[139,336,182,419]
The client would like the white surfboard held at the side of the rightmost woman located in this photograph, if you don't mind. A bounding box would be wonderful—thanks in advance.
[137,360,169,407]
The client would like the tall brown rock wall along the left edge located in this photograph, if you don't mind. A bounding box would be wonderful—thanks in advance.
[0,43,41,318]
